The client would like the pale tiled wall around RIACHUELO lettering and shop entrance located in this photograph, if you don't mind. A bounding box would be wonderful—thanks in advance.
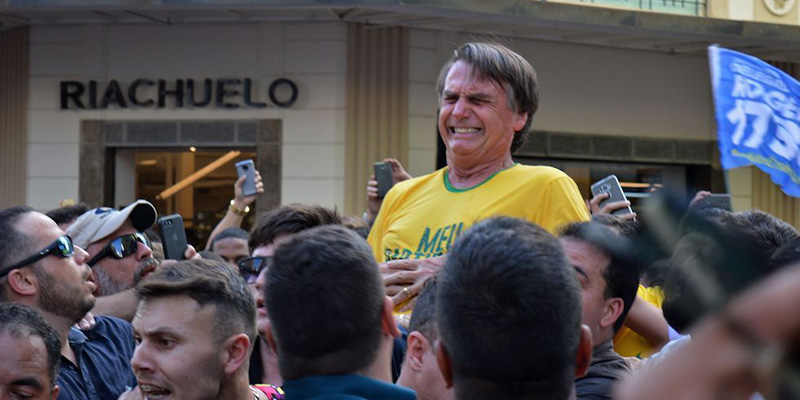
[26,23,347,209]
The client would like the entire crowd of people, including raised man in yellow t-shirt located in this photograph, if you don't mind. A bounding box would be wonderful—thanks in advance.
[0,43,800,400]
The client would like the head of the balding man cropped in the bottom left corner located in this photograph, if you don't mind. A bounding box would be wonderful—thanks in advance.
[0,303,61,399]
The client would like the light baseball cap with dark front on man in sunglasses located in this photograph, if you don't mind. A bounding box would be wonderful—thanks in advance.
[67,200,158,249]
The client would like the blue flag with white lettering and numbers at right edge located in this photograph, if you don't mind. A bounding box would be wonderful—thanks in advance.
[708,46,800,197]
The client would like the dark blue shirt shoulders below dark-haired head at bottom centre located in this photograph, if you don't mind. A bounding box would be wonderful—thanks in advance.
[283,375,417,400]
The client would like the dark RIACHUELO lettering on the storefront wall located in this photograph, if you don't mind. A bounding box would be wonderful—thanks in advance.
[60,78,298,110]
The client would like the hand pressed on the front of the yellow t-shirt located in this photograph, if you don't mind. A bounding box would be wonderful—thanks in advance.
[379,256,446,307]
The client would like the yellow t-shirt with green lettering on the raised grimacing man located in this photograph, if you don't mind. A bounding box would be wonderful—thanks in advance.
[367,164,589,263]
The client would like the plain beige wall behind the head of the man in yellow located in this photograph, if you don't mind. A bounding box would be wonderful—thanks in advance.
[409,29,716,177]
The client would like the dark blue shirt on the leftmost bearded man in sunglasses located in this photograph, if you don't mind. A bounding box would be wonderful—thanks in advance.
[56,317,136,400]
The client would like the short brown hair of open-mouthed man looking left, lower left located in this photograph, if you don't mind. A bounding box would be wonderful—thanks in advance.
[136,260,253,345]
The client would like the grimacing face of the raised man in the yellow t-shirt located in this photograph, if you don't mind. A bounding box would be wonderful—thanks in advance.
[439,61,527,165]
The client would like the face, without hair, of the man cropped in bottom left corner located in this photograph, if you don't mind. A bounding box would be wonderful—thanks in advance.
[0,333,59,400]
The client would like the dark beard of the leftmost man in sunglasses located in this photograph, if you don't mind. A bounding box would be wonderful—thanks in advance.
[33,267,95,322]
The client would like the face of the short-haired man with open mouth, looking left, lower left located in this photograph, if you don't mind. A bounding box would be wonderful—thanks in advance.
[131,295,225,400]
